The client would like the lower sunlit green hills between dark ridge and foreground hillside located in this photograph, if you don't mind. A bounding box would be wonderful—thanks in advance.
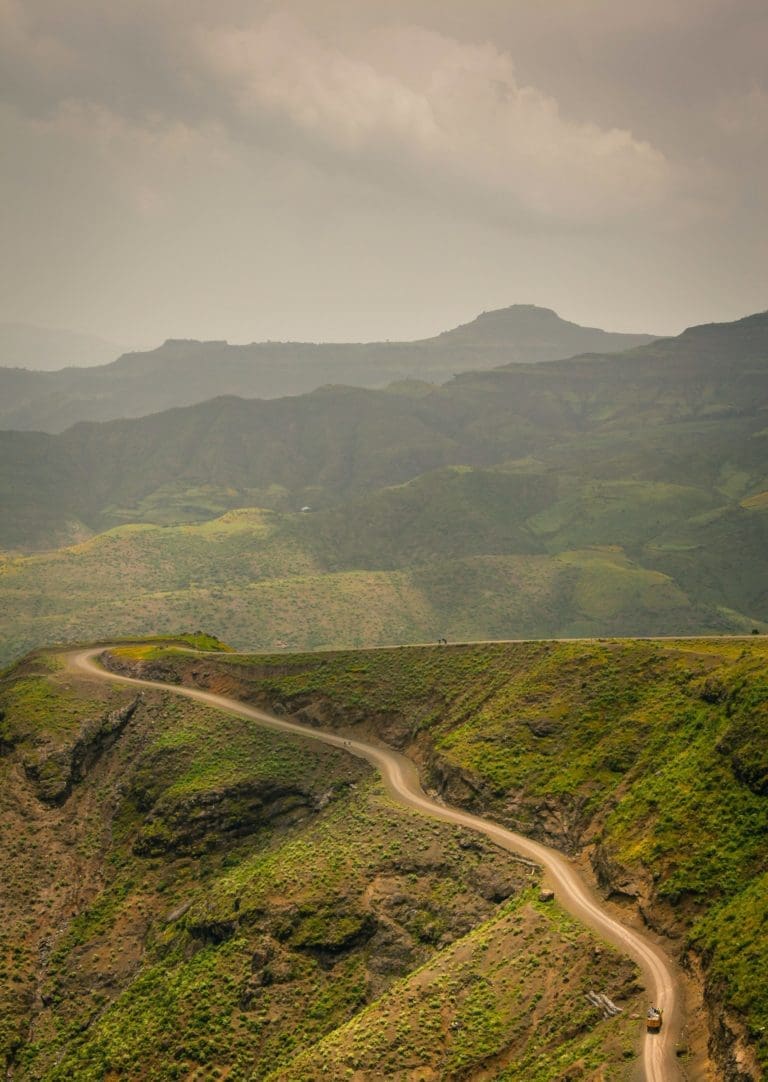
[0,497,764,661]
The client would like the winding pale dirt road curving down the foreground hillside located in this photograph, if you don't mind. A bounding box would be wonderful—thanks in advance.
[72,646,683,1082]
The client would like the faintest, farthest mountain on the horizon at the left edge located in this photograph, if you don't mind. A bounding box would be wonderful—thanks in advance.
[0,324,124,371]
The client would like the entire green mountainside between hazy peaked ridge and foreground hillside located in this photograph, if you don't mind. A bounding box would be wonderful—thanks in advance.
[0,313,768,649]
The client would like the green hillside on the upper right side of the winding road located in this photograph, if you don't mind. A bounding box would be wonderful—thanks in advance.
[133,638,768,1078]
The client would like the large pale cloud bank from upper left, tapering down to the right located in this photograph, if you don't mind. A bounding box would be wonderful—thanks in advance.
[2,0,673,222]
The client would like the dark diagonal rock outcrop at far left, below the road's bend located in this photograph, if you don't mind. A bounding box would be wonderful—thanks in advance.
[23,695,142,805]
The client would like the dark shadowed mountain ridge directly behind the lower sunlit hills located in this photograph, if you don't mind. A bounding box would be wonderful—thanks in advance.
[0,313,768,545]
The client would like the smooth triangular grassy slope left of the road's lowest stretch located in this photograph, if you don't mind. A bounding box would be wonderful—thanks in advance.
[269,894,637,1082]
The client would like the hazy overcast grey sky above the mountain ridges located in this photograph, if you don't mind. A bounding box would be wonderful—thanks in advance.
[0,0,768,345]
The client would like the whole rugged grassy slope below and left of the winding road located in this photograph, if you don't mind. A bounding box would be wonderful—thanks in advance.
[0,641,643,1082]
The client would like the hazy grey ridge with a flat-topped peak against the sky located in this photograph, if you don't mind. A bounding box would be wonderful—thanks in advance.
[0,304,652,432]
